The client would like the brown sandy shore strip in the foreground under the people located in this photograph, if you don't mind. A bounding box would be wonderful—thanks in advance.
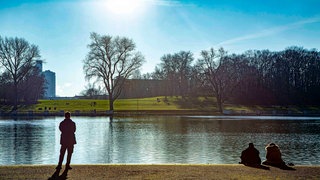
[0,164,320,180]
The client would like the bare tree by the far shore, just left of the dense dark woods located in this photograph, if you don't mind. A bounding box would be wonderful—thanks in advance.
[196,48,239,112]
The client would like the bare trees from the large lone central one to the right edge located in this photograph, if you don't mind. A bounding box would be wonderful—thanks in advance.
[84,33,320,111]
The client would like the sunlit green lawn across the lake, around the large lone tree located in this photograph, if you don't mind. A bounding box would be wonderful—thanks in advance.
[30,97,216,112]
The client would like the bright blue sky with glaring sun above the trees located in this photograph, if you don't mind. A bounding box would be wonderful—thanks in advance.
[0,0,320,97]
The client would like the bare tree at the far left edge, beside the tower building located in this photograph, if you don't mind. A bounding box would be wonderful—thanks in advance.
[0,36,40,109]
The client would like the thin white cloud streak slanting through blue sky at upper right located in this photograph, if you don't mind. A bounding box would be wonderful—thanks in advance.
[217,17,320,46]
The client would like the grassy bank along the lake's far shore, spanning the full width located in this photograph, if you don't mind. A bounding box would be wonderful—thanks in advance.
[0,96,320,115]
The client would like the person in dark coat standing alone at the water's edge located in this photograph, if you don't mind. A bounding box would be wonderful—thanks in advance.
[56,112,77,169]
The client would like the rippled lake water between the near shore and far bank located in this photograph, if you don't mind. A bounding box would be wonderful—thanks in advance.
[0,116,320,165]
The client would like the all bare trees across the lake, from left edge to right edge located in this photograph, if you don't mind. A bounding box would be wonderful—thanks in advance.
[0,33,320,111]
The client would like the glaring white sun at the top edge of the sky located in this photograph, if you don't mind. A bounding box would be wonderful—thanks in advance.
[106,0,147,15]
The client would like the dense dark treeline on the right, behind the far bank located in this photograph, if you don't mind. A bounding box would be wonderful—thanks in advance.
[231,47,320,105]
